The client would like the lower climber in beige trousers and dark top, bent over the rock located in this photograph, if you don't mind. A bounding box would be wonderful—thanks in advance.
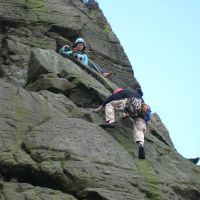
[94,88,151,159]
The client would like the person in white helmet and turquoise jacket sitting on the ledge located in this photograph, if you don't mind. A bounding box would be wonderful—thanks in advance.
[59,38,112,78]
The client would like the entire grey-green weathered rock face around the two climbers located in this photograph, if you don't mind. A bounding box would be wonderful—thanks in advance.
[0,0,200,200]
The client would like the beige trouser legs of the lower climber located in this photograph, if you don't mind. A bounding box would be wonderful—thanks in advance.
[105,98,146,145]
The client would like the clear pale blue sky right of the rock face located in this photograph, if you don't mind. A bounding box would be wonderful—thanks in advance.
[97,0,200,163]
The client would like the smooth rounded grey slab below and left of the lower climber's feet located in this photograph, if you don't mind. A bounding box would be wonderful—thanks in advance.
[24,118,132,168]
